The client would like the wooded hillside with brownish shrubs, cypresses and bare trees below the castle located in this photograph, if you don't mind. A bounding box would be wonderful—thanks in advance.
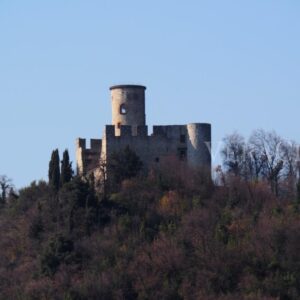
[0,131,300,300]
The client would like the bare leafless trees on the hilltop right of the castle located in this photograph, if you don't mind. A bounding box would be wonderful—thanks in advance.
[219,130,300,196]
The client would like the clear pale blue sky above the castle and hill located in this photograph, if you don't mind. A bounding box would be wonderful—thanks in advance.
[0,0,300,187]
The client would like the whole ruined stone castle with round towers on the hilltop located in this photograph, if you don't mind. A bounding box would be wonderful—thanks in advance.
[76,85,211,180]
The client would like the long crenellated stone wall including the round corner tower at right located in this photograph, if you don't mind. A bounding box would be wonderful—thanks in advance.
[101,123,211,176]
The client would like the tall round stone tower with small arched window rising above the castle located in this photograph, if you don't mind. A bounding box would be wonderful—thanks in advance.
[110,85,146,136]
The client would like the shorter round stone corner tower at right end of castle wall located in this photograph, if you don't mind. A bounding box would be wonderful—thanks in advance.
[187,123,211,172]
